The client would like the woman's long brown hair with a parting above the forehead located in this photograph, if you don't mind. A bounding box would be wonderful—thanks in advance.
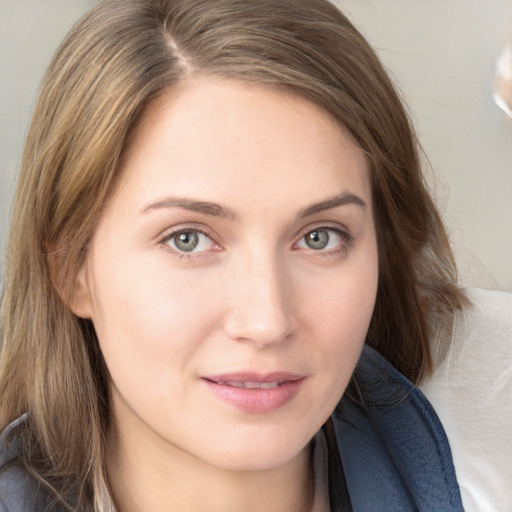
[0,0,464,510]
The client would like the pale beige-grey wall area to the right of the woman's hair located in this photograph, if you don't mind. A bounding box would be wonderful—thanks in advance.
[336,0,512,291]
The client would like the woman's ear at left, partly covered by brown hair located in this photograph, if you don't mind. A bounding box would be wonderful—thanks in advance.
[48,246,93,318]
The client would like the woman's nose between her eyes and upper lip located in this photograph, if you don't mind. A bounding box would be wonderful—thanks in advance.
[224,253,296,348]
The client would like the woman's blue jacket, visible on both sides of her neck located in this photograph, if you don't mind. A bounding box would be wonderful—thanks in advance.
[0,346,464,512]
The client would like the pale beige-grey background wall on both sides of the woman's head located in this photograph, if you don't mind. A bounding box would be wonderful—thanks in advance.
[0,0,512,291]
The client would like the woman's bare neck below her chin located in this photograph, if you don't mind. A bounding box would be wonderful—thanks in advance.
[106,414,314,512]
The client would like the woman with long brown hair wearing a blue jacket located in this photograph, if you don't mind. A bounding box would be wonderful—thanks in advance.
[0,0,472,512]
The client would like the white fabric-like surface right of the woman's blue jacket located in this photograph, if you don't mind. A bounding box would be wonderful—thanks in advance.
[421,289,512,512]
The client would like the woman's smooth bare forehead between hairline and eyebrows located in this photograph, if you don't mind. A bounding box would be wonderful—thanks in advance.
[117,78,370,212]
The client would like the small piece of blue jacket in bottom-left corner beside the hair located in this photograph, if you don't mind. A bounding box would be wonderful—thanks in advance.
[0,416,49,512]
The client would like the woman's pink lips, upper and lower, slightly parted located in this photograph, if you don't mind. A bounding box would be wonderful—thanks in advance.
[202,372,305,413]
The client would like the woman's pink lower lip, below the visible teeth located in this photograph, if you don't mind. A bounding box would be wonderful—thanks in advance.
[204,378,304,413]
